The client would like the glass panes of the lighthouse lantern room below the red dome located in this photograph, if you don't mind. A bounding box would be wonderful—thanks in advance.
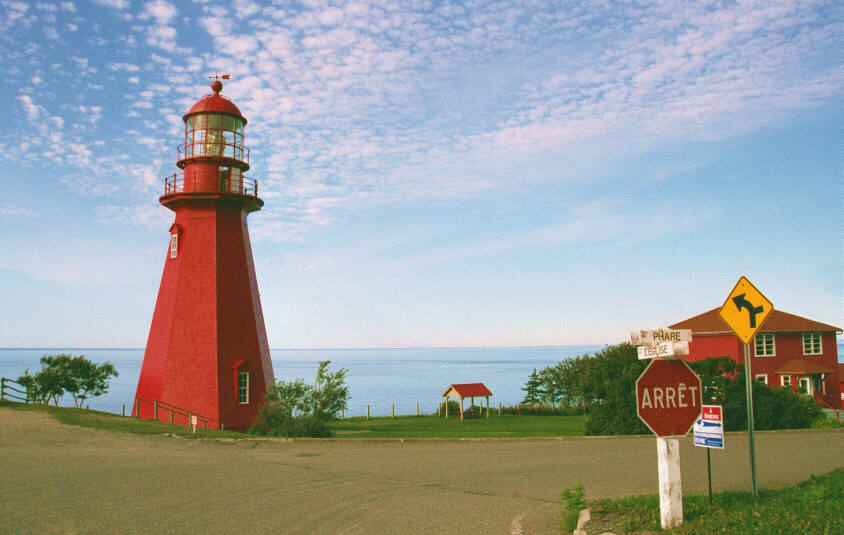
[185,113,243,161]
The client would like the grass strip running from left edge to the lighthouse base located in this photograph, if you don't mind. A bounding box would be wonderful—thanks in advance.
[0,400,244,438]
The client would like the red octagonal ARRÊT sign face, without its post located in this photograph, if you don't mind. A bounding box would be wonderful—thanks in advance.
[636,359,701,437]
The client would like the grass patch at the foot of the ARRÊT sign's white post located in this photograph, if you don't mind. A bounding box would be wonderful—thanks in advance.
[586,468,844,535]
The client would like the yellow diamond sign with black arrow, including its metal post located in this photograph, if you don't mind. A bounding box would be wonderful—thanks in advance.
[718,276,774,496]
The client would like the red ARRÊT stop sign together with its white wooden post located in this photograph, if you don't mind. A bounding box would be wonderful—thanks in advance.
[636,344,701,529]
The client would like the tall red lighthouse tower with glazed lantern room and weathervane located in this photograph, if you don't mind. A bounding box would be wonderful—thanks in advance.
[134,80,274,430]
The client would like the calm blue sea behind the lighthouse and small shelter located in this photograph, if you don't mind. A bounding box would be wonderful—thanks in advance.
[0,346,602,416]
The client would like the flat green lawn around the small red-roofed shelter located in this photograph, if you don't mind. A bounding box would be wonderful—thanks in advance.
[328,414,586,438]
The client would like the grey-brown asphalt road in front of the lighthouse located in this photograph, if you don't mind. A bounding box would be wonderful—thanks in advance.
[0,408,844,535]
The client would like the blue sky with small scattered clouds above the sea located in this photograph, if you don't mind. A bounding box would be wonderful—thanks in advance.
[0,0,844,347]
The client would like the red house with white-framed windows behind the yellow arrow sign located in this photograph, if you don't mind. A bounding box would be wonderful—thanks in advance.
[671,308,842,409]
